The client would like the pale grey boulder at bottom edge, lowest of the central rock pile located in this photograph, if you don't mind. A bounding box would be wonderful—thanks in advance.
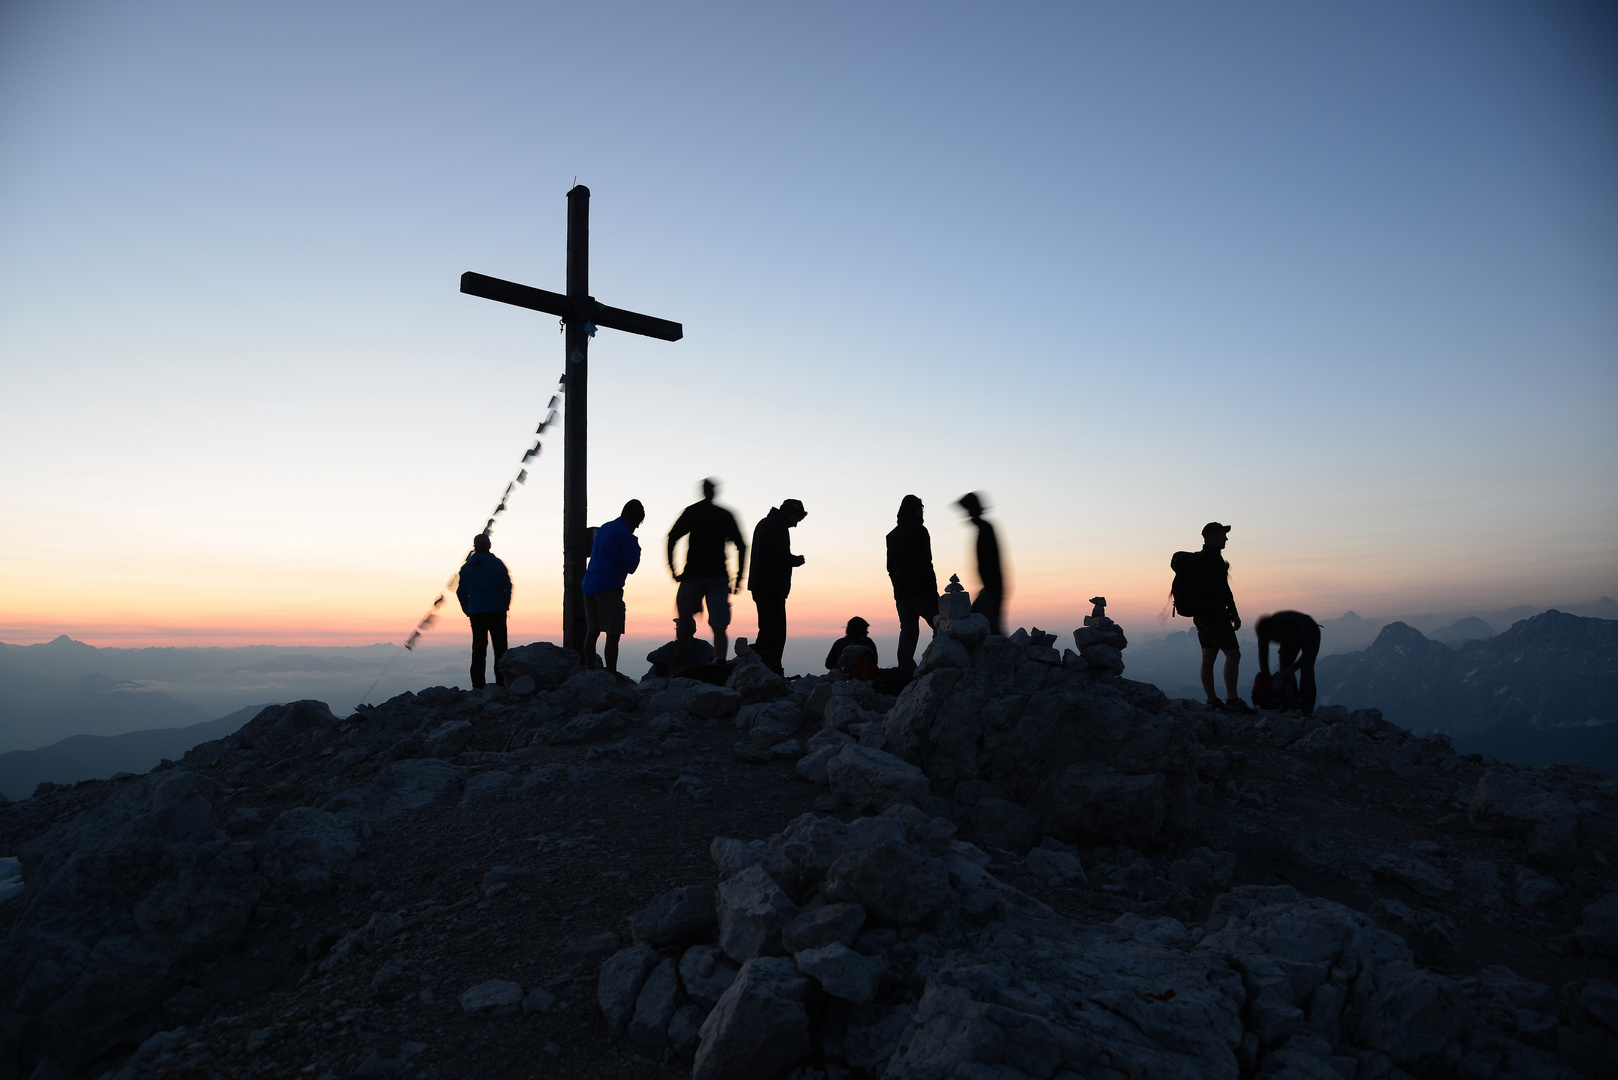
[691,957,814,1080]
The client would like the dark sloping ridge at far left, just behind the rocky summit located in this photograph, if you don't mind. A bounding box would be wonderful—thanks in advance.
[0,705,269,798]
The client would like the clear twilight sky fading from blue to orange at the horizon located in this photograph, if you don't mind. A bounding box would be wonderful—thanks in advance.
[0,0,1618,644]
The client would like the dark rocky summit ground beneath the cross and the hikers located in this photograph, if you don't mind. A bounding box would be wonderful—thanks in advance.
[0,615,1618,1080]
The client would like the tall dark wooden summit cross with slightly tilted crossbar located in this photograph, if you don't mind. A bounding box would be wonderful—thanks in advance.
[461,185,684,649]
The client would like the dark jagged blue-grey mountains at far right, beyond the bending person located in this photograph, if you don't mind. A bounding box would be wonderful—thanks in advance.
[1319,610,1618,769]
